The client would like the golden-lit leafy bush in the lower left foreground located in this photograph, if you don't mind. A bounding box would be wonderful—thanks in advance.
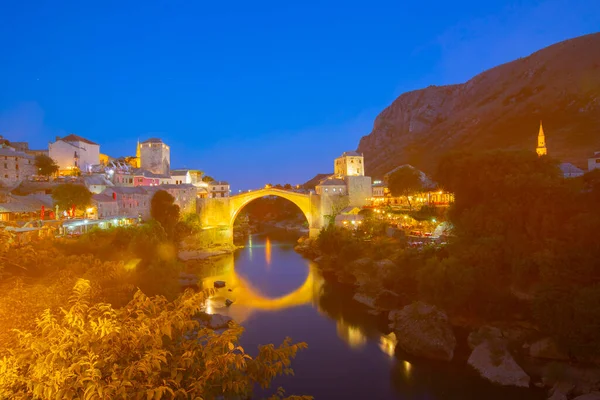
[0,280,306,399]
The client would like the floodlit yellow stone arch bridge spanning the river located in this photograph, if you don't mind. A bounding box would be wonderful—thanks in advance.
[198,188,324,243]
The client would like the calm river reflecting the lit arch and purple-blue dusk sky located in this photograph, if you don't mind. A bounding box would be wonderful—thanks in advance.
[203,232,544,400]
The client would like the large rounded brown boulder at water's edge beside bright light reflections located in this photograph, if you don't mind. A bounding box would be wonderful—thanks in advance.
[388,302,456,361]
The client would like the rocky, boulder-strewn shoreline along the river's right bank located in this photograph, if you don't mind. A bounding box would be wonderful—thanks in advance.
[295,238,600,400]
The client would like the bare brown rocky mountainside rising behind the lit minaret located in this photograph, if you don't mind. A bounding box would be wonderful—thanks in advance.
[358,33,600,177]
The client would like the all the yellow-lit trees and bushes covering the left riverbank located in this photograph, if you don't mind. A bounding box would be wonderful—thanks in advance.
[0,199,308,399]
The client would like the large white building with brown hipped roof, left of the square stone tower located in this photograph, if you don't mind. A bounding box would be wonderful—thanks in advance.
[48,134,100,174]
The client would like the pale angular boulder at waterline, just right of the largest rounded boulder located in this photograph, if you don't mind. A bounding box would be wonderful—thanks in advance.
[467,338,529,387]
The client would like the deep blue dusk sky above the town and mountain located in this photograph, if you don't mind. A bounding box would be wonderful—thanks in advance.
[0,0,600,190]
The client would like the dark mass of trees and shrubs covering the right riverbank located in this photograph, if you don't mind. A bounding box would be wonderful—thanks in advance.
[318,151,600,356]
